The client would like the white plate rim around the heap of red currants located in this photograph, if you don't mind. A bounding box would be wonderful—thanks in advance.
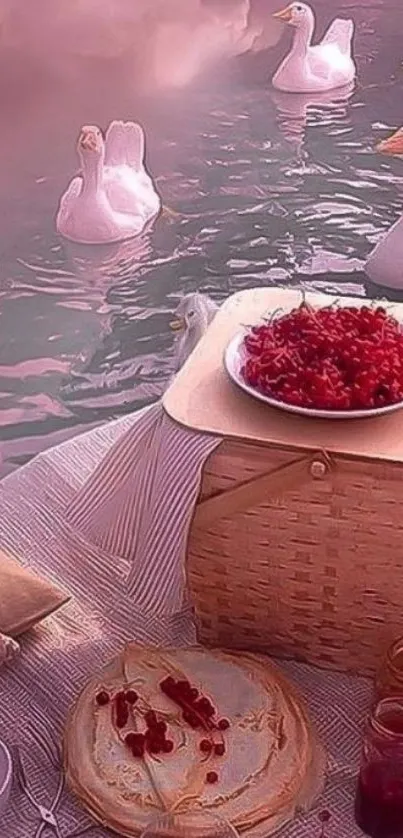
[224,329,403,419]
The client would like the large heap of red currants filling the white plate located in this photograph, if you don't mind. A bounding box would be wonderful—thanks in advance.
[242,301,403,411]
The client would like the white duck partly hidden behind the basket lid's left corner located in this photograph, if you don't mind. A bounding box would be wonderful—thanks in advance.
[171,293,218,370]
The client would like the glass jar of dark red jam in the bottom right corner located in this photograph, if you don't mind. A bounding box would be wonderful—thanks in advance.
[355,695,403,838]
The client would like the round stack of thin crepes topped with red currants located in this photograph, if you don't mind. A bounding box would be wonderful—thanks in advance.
[65,644,324,836]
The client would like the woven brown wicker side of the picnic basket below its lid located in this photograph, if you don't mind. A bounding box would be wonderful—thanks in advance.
[187,440,403,674]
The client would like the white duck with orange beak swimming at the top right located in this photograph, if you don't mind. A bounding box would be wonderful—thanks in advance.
[273,2,356,93]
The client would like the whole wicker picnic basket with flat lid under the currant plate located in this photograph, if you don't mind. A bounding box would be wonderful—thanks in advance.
[165,290,403,674]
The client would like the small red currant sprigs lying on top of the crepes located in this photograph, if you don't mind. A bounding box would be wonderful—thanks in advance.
[95,675,230,783]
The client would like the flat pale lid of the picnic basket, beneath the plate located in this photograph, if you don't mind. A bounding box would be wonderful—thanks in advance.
[163,288,403,462]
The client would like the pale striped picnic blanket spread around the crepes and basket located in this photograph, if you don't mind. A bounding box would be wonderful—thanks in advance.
[0,405,368,838]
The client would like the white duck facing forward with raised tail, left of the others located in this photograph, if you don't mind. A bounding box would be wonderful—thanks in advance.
[56,121,161,244]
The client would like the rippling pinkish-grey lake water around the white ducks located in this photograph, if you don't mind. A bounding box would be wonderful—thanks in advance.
[0,0,403,474]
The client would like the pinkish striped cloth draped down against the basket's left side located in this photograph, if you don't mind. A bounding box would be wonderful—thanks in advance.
[67,402,221,616]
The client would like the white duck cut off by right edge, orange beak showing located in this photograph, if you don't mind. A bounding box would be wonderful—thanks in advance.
[364,128,403,289]
